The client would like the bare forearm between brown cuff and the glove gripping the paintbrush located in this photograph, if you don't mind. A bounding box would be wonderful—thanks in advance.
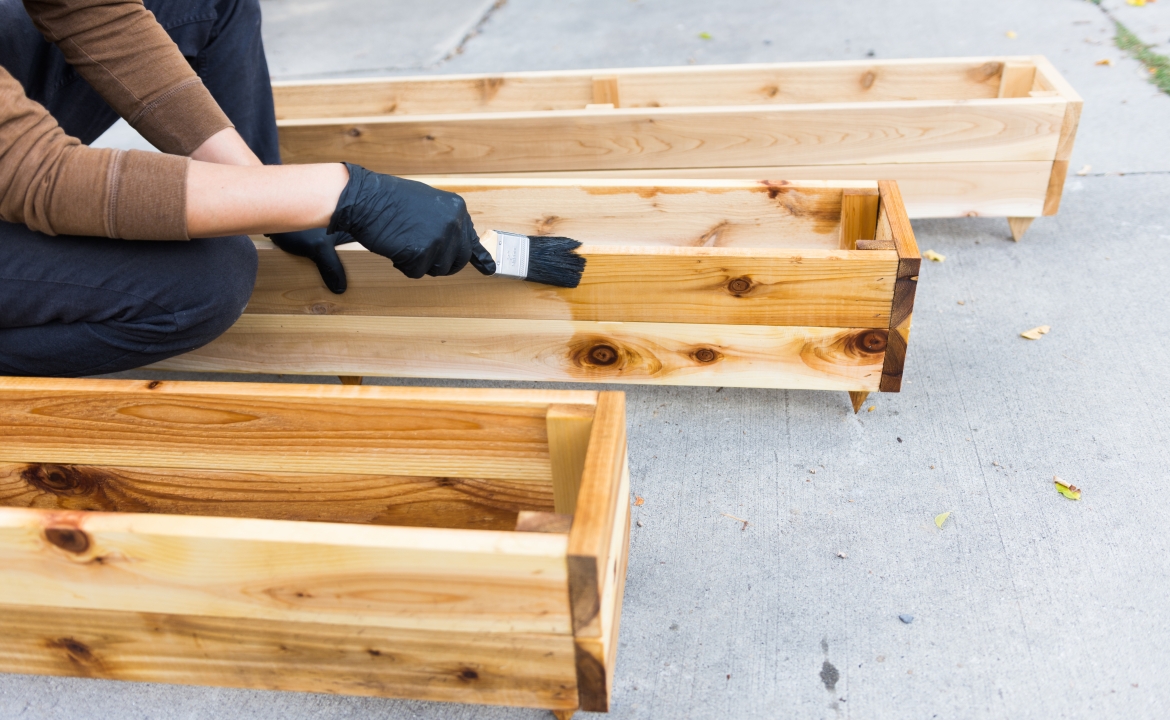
[186,160,349,238]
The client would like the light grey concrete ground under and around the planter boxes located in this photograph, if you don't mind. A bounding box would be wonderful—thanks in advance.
[16,0,1170,720]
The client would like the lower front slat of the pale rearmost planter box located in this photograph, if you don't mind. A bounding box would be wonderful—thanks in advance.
[418,160,1052,218]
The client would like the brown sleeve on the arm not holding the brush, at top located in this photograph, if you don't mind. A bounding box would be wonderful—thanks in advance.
[23,0,233,155]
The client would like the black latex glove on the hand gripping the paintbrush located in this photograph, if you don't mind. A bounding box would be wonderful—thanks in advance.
[329,163,496,277]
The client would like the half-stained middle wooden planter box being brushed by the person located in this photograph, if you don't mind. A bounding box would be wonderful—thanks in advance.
[156,179,920,407]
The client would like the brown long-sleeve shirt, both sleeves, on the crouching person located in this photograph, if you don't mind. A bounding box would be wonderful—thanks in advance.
[0,0,232,240]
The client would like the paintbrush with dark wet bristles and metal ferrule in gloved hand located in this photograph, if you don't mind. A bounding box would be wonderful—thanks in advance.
[480,229,585,288]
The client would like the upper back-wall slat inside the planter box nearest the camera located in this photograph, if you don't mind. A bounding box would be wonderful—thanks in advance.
[0,379,575,481]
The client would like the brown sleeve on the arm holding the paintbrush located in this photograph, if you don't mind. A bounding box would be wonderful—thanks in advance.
[0,68,191,240]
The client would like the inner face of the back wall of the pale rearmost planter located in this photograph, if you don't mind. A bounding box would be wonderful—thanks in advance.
[273,56,1031,119]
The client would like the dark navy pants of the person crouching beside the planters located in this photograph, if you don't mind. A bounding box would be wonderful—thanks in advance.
[0,0,280,377]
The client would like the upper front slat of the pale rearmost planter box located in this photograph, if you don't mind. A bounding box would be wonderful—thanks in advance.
[281,97,1066,174]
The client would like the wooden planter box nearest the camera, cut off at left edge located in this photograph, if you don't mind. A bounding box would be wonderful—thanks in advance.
[0,378,629,718]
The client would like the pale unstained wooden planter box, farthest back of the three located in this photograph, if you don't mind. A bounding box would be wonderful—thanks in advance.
[273,55,1081,239]
